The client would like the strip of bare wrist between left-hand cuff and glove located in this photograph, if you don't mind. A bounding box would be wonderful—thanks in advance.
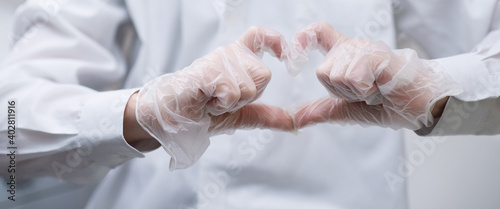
[123,93,160,148]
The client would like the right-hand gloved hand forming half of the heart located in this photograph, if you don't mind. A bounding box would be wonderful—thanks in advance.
[287,22,461,130]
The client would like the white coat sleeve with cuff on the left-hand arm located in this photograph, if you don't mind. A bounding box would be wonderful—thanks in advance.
[0,0,147,183]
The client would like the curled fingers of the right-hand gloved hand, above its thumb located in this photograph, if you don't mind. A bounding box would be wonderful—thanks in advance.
[316,38,390,105]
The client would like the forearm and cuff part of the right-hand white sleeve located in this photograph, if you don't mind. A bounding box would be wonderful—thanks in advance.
[416,3,500,135]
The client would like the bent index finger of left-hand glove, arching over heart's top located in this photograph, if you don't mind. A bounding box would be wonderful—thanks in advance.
[238,26,288,60]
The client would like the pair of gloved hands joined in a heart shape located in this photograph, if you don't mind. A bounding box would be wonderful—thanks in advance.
[136,23,456,169]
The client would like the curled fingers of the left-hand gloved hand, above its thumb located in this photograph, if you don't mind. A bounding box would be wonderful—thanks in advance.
[202,38,271,115]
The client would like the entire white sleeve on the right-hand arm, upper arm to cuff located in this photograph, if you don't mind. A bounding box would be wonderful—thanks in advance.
[396,0,500,135]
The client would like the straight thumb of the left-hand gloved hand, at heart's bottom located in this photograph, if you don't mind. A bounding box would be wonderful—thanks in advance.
[210,104,294,131]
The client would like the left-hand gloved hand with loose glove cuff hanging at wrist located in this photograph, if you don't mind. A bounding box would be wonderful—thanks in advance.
[136,27,293,170]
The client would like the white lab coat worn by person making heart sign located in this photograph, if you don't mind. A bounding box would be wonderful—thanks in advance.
[0,0,500,208]
